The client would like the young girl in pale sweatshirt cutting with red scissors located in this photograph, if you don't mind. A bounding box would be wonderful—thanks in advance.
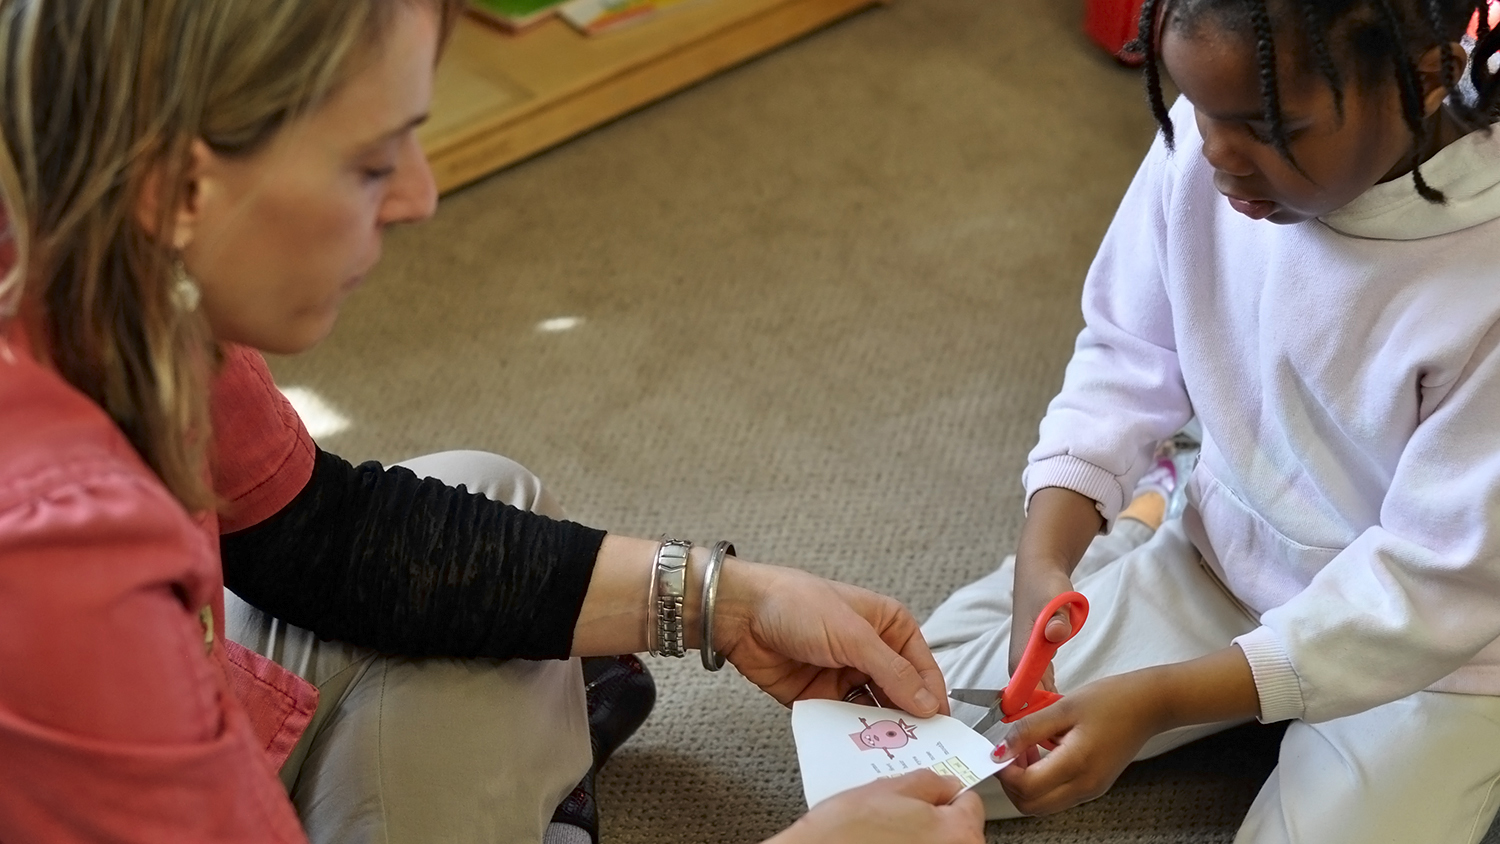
[924,0,1500,844]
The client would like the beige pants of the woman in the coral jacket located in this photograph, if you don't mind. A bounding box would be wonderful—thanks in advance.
[225,451,593,844]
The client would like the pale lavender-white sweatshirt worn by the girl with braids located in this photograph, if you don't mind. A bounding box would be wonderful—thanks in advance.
[1025,100,1500,721]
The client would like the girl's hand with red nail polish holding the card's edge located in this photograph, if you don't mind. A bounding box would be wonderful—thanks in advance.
[999,669,1170,814]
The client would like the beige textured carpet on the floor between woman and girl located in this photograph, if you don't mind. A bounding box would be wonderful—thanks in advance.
[258,0,1452,844]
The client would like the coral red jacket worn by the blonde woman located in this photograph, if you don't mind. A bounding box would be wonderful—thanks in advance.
[0,337,317,844]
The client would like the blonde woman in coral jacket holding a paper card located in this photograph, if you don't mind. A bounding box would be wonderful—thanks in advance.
[0,0,981,844]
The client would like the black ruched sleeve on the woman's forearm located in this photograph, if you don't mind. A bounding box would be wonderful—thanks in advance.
[219,450,605,660]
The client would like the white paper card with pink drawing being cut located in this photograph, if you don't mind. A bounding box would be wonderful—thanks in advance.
[792,700,1010,808]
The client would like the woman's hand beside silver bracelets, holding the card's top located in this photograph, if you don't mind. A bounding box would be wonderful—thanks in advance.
[714,559,948,718]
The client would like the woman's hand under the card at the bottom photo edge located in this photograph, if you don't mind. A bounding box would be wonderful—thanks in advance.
[767,771,984,844]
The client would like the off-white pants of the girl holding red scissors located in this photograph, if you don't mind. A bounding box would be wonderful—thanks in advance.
[923,520,1500,844]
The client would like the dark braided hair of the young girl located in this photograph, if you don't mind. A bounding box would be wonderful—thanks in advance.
[1131,0,1500,202]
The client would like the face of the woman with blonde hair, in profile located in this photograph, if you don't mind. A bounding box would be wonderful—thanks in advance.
[177,3,438,354]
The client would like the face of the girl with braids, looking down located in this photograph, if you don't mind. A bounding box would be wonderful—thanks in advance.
[1161,19,1412,223]
